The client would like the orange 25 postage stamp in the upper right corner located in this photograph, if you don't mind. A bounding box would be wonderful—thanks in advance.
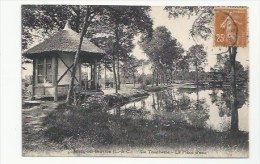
[214,8,247,47]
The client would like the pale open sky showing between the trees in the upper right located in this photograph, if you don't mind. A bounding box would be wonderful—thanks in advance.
[133,6,249,73]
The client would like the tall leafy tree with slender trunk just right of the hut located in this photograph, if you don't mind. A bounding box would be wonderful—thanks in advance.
[89,6,152,93]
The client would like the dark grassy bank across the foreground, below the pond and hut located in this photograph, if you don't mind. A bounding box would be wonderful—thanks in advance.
[23,97,248,156]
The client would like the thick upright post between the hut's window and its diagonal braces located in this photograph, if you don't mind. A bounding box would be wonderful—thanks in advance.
[52,56,58,101]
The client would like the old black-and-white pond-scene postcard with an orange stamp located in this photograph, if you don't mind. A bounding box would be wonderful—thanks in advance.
[20,4,251,158]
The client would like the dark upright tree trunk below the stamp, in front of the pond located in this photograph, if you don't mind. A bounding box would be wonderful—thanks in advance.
[231,47,238,132]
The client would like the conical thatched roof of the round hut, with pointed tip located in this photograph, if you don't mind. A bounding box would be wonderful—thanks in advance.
[23,24,105,58]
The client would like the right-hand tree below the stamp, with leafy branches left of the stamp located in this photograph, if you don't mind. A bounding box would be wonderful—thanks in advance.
[165,6,243,132]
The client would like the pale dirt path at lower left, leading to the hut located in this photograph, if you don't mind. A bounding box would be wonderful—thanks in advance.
[22,101,58,152]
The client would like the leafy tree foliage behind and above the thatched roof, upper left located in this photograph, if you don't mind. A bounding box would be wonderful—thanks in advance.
[22,5,85,49]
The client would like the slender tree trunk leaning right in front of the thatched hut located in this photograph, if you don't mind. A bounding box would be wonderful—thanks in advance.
[66,10,89,105]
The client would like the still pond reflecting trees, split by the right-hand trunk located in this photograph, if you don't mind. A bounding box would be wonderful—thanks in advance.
[109,86,249,132]
